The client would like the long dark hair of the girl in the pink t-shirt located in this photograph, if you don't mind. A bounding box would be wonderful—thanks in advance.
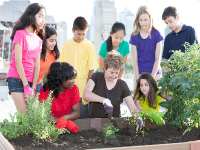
[10,3,45,41]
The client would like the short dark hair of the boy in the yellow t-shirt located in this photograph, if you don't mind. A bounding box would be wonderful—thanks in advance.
[73,16,88,31]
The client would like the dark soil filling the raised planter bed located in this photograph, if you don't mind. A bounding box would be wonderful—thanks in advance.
[10,125,200,150]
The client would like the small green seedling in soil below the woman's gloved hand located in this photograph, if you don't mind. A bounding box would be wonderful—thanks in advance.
[102,123,119,139]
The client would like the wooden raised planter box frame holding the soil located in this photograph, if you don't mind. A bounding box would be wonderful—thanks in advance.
[0,118,200,150]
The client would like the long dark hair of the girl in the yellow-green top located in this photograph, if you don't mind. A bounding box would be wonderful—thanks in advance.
[133,72,164,109]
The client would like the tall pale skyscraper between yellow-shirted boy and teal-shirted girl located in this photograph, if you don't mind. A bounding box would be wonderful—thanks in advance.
[90,0,117,58]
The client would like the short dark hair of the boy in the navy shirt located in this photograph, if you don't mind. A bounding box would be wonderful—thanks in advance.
[162,6,179,20]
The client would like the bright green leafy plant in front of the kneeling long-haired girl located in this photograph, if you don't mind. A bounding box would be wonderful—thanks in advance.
[124,110,165,135]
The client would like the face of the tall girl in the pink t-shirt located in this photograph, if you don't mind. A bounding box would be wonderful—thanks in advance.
[35,8,46,29]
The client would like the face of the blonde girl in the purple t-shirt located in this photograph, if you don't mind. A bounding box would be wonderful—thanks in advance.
[139,13,150,30]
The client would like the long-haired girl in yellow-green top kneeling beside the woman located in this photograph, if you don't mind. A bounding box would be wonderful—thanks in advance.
[133,72,166,112]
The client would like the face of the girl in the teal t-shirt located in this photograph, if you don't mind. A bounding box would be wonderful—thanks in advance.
[110,30,124,48]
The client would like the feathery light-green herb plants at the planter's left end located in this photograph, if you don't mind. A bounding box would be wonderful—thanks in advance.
[0,93,66,141]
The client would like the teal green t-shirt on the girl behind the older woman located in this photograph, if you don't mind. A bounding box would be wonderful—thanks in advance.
[95,41,130,72]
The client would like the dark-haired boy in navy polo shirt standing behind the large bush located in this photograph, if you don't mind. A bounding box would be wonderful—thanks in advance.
[162,6,198,61]
